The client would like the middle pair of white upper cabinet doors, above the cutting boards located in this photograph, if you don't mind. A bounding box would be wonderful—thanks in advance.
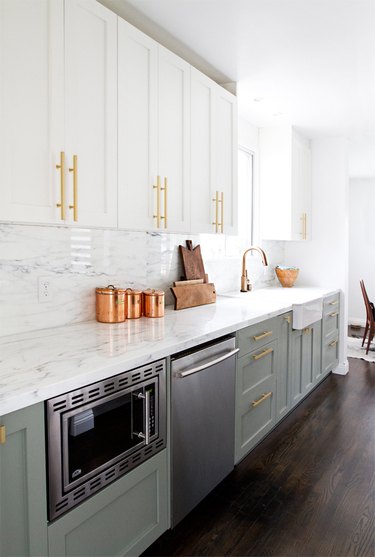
[118,23,190,232]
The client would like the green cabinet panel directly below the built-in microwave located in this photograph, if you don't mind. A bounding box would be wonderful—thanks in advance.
[48,450,169,557]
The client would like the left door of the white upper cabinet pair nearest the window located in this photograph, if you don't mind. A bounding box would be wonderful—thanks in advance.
[190,68,219,234]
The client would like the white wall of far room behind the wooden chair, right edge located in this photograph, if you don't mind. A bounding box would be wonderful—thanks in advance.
[348,178,375,326]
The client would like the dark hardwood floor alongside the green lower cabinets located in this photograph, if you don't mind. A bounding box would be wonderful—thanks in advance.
[144,359,375,557]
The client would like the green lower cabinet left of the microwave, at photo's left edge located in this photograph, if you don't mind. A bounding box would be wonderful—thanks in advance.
[0,403,48,557]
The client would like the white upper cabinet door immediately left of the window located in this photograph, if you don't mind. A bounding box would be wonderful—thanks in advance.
[214,86,238,234]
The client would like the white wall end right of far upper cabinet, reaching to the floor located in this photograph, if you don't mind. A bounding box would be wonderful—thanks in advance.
[285,138,349,373]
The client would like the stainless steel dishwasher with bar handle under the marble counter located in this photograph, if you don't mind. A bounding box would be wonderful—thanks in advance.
[171,337,238,527]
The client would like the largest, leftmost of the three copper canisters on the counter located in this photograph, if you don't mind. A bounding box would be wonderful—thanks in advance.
[95,284,126,323]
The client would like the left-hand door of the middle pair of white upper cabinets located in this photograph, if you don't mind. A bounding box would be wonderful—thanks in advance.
[118,18,158,230]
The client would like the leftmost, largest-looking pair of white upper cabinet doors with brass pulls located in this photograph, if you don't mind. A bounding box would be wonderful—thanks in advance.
[0,0,117,226]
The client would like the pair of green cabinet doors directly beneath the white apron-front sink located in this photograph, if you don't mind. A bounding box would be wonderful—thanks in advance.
[290,321,322,407]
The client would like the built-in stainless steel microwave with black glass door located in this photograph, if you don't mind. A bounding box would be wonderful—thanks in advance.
[46,360,166,520]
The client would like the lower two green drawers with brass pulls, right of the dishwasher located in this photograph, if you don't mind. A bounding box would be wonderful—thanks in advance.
[235,341,278,463]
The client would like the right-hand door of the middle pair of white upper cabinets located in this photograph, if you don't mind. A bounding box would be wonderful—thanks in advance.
[158,45,190,232]
